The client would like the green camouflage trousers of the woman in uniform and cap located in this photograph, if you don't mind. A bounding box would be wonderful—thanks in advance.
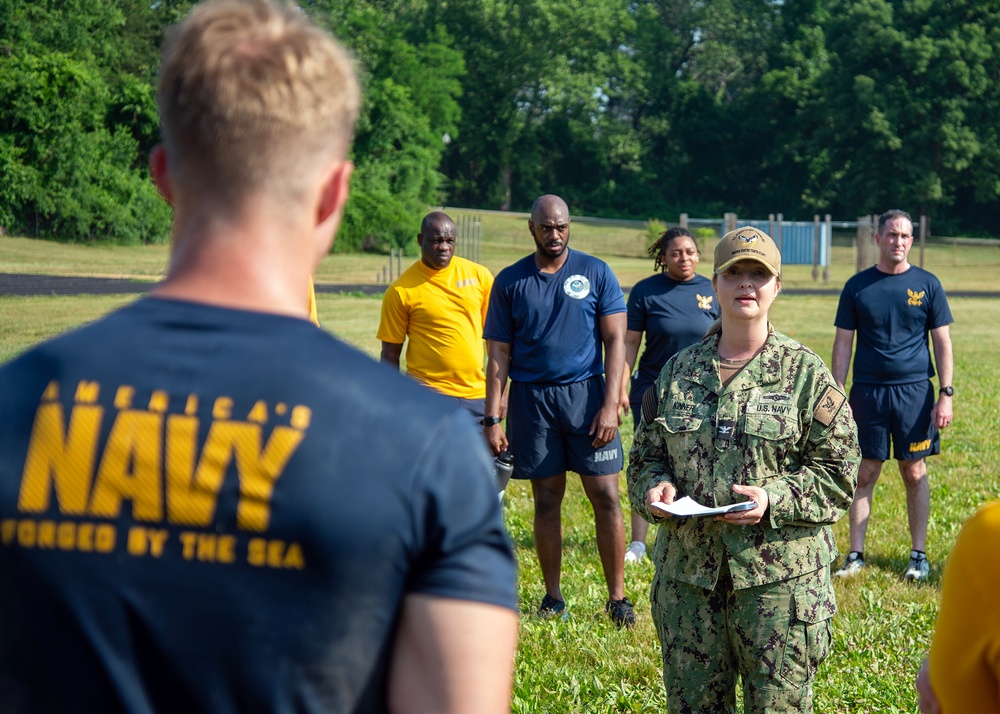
[650,567,837,714]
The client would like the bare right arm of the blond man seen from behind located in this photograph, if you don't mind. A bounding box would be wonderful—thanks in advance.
[389,595,517,714]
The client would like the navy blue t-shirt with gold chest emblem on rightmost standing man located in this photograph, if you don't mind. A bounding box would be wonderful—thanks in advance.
[833,265,953,384]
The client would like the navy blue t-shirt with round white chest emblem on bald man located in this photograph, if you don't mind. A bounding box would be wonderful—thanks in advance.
[483,248,625,384]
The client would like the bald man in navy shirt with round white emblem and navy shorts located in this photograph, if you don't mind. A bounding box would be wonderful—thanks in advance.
[483,195,635,627]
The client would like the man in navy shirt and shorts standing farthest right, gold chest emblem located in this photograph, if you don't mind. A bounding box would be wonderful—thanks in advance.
[831,209,955,582]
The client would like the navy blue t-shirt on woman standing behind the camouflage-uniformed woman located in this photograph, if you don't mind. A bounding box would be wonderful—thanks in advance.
[628,273,720,404]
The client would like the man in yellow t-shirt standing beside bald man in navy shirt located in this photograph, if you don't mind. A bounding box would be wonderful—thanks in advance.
[378,211,493,420]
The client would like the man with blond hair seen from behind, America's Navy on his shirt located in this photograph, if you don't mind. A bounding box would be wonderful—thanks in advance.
[0,0,517,714]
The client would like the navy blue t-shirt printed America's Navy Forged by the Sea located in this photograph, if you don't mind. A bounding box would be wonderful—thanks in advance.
[0,298,516,714]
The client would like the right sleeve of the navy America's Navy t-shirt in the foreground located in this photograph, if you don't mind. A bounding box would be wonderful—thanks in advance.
[409,411,517,610]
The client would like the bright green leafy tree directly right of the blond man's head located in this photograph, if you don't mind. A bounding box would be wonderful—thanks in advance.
[310,0,464,251]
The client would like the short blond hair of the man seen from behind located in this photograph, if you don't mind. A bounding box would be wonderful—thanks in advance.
[157,0,361,200]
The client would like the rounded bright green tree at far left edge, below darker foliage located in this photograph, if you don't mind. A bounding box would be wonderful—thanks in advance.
[0,52,169,242]
